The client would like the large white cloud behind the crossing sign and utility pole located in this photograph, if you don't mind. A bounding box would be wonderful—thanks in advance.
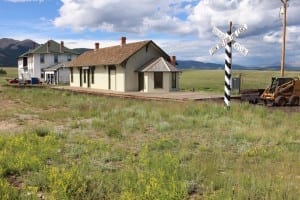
[188,0,300,65]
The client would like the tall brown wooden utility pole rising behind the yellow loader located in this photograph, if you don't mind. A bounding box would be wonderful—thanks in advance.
[280,0,288,77]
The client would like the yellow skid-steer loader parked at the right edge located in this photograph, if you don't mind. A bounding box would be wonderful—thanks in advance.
[260,77,300,106]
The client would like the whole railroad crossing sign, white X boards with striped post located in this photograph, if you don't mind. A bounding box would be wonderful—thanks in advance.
[209,22,249,110]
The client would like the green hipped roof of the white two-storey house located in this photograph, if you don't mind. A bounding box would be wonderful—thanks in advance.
[19,40,79,58]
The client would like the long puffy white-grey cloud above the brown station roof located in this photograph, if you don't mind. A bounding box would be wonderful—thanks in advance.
[54,0,193,34]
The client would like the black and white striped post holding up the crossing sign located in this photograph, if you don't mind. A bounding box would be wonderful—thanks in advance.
[224,22,232,109]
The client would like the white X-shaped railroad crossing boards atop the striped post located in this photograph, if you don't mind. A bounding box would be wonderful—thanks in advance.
[209,24,249,56]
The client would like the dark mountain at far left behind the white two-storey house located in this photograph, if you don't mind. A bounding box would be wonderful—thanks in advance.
[0,38,39,66]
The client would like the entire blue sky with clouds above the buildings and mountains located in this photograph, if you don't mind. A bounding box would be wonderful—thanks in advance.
[0,0,300,67]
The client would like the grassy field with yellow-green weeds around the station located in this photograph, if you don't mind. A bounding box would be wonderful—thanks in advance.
[0,68,300,200]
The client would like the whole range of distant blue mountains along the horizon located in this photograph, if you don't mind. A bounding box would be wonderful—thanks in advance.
[0,38,300,71]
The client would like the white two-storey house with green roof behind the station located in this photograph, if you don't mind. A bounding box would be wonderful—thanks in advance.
[18,40,79,84]
